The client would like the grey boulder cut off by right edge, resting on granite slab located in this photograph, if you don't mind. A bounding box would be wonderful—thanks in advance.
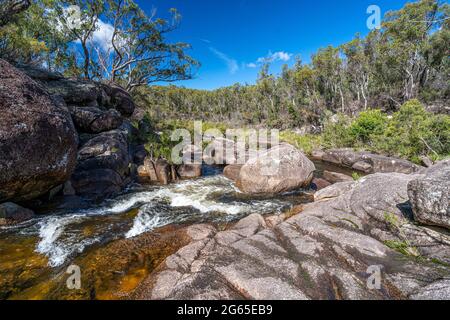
[408,161,450,229]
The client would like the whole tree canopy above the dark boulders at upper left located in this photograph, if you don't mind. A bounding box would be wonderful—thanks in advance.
[0,0,199,91]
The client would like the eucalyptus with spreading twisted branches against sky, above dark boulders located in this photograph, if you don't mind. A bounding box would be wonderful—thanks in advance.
[96,0,199,91]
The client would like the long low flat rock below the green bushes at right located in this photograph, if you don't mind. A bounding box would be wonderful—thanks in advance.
[313,149,420,174]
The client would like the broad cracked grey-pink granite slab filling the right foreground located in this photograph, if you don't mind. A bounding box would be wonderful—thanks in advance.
[131,165,450,300]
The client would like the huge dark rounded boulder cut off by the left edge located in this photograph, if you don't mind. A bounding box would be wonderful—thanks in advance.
[0,59,78,202]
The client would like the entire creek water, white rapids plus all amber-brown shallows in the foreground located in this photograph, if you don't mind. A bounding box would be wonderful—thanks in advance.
[0,163,351,299]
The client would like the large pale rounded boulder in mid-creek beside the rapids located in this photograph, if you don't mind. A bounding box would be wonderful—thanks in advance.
[236,144,316,194]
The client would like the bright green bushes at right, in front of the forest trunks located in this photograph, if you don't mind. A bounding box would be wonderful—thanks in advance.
[323,100,450,163]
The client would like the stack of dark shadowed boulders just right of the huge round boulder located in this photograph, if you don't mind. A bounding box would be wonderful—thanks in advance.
[10,66,139,201]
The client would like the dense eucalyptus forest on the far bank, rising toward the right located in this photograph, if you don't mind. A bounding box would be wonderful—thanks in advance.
[135,0,450,129]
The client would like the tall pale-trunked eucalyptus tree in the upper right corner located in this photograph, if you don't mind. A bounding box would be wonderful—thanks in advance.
[378,0,448,101]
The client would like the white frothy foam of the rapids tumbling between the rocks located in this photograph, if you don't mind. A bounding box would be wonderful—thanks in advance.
[36,176,296,267]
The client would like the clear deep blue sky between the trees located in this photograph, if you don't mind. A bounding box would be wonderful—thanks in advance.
[137,0,414,89]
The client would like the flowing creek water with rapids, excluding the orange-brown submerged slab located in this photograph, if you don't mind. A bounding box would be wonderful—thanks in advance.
[0,167,318,298]
